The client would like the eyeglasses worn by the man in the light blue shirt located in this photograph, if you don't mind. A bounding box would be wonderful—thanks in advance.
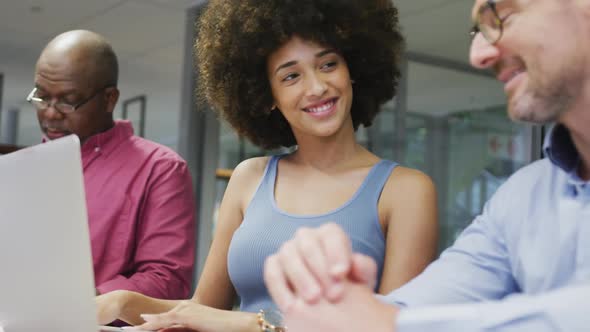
[469,0,506,45]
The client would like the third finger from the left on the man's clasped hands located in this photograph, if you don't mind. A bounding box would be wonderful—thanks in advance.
[294,228,335,292]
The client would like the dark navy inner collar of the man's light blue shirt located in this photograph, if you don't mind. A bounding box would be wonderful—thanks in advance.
[543,124,580,174]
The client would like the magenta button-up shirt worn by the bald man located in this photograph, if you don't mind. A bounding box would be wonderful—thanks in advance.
[82,121,195,299]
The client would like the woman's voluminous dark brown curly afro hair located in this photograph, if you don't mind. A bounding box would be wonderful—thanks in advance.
[195,0,404,149]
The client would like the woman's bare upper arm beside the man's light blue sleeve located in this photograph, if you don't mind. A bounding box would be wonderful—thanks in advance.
[379,167,438,294]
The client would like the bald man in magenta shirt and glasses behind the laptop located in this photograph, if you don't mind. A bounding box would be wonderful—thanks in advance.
[27,30,195,310]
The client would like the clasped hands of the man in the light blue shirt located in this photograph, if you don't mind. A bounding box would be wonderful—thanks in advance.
[264,224,398,332]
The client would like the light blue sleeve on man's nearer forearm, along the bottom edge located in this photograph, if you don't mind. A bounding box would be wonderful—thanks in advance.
[396,282,590,332]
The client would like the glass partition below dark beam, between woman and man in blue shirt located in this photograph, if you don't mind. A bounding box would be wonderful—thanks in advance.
[367,61,540,250]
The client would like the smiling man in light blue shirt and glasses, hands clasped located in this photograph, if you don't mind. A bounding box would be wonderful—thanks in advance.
[265,0,590,332]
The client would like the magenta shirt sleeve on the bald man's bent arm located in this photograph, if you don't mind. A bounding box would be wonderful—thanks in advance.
[97,160,195,299]
